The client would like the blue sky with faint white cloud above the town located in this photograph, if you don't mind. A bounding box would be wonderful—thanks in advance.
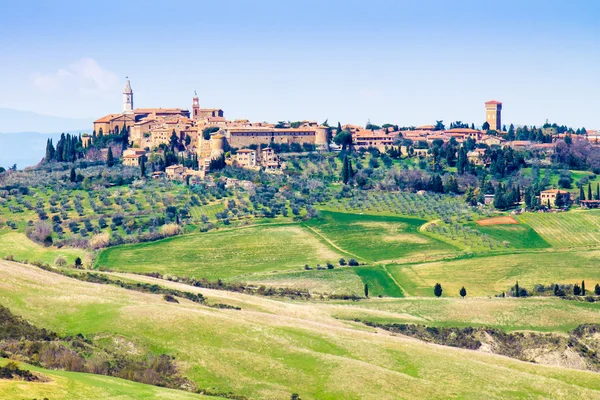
[0,0,600,129]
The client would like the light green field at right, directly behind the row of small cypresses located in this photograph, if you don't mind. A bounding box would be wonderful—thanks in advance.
[387,250,600,296]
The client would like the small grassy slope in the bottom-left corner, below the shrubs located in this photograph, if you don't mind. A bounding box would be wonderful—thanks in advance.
[0,359,218,400]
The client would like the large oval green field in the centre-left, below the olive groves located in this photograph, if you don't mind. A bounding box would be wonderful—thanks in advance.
[97,225,341,279]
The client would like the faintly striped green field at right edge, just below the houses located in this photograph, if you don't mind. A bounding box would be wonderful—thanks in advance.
[517,210,600,248]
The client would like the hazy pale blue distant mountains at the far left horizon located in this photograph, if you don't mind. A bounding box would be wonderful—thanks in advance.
[0,108,93,169]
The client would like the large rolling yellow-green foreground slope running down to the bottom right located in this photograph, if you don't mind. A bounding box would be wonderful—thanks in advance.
[0,262,600,400]
